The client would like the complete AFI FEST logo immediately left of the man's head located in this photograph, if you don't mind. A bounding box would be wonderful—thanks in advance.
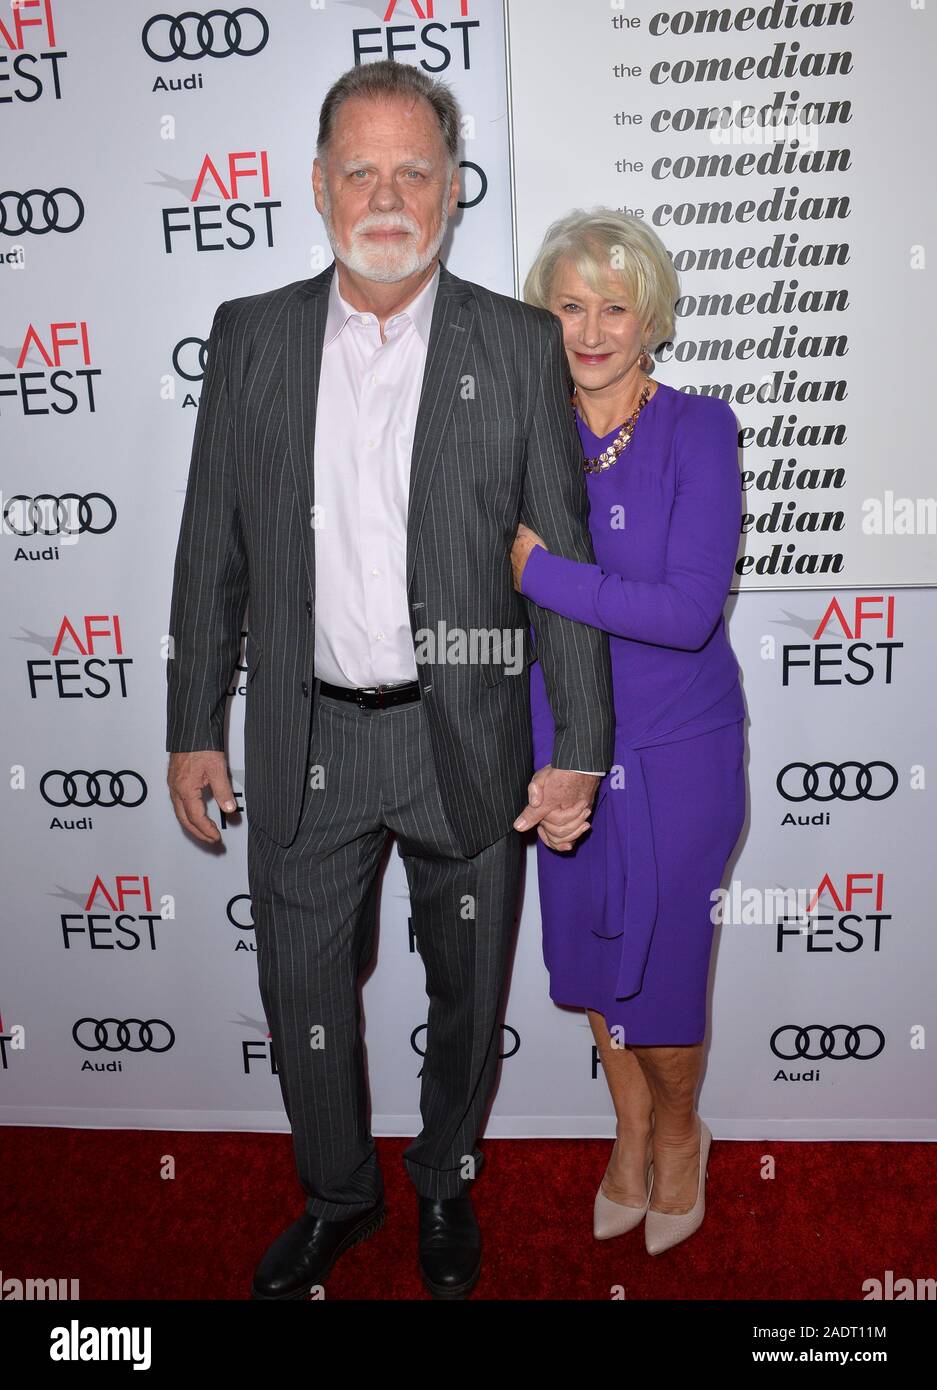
[163,150,282,256]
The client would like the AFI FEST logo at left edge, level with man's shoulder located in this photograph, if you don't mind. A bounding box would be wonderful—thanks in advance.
[0,320,101,416]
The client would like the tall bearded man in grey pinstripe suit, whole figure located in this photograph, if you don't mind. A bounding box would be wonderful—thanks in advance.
[167,63,613,1298]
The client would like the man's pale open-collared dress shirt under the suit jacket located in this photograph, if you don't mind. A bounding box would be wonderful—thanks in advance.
[313,264,602,777]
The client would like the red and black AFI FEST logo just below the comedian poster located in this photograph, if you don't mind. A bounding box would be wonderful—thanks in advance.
[781,594,905,685]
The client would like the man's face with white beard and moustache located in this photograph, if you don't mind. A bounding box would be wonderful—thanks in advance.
[313,97,459,282]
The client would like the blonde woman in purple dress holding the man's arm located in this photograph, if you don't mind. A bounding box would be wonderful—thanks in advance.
[512,209,745,1254]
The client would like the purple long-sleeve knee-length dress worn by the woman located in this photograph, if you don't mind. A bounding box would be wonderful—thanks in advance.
[521,382,745,1047]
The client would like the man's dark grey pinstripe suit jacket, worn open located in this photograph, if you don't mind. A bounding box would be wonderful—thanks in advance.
[165,261,613,855]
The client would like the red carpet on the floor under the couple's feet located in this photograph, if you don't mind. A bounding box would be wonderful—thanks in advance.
[0,1129,937,1300]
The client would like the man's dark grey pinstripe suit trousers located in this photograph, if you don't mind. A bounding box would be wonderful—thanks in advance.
[247,681,521,1219]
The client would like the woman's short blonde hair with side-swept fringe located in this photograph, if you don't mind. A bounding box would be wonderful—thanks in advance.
[524,207,680,349]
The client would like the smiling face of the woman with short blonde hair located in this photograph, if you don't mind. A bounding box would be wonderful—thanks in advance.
[548,260,646,391]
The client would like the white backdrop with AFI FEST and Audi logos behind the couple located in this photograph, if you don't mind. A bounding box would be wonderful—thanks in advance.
[0,0,937,1138]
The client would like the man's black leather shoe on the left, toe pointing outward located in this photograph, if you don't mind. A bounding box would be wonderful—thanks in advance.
[250,1198,386,1298]
